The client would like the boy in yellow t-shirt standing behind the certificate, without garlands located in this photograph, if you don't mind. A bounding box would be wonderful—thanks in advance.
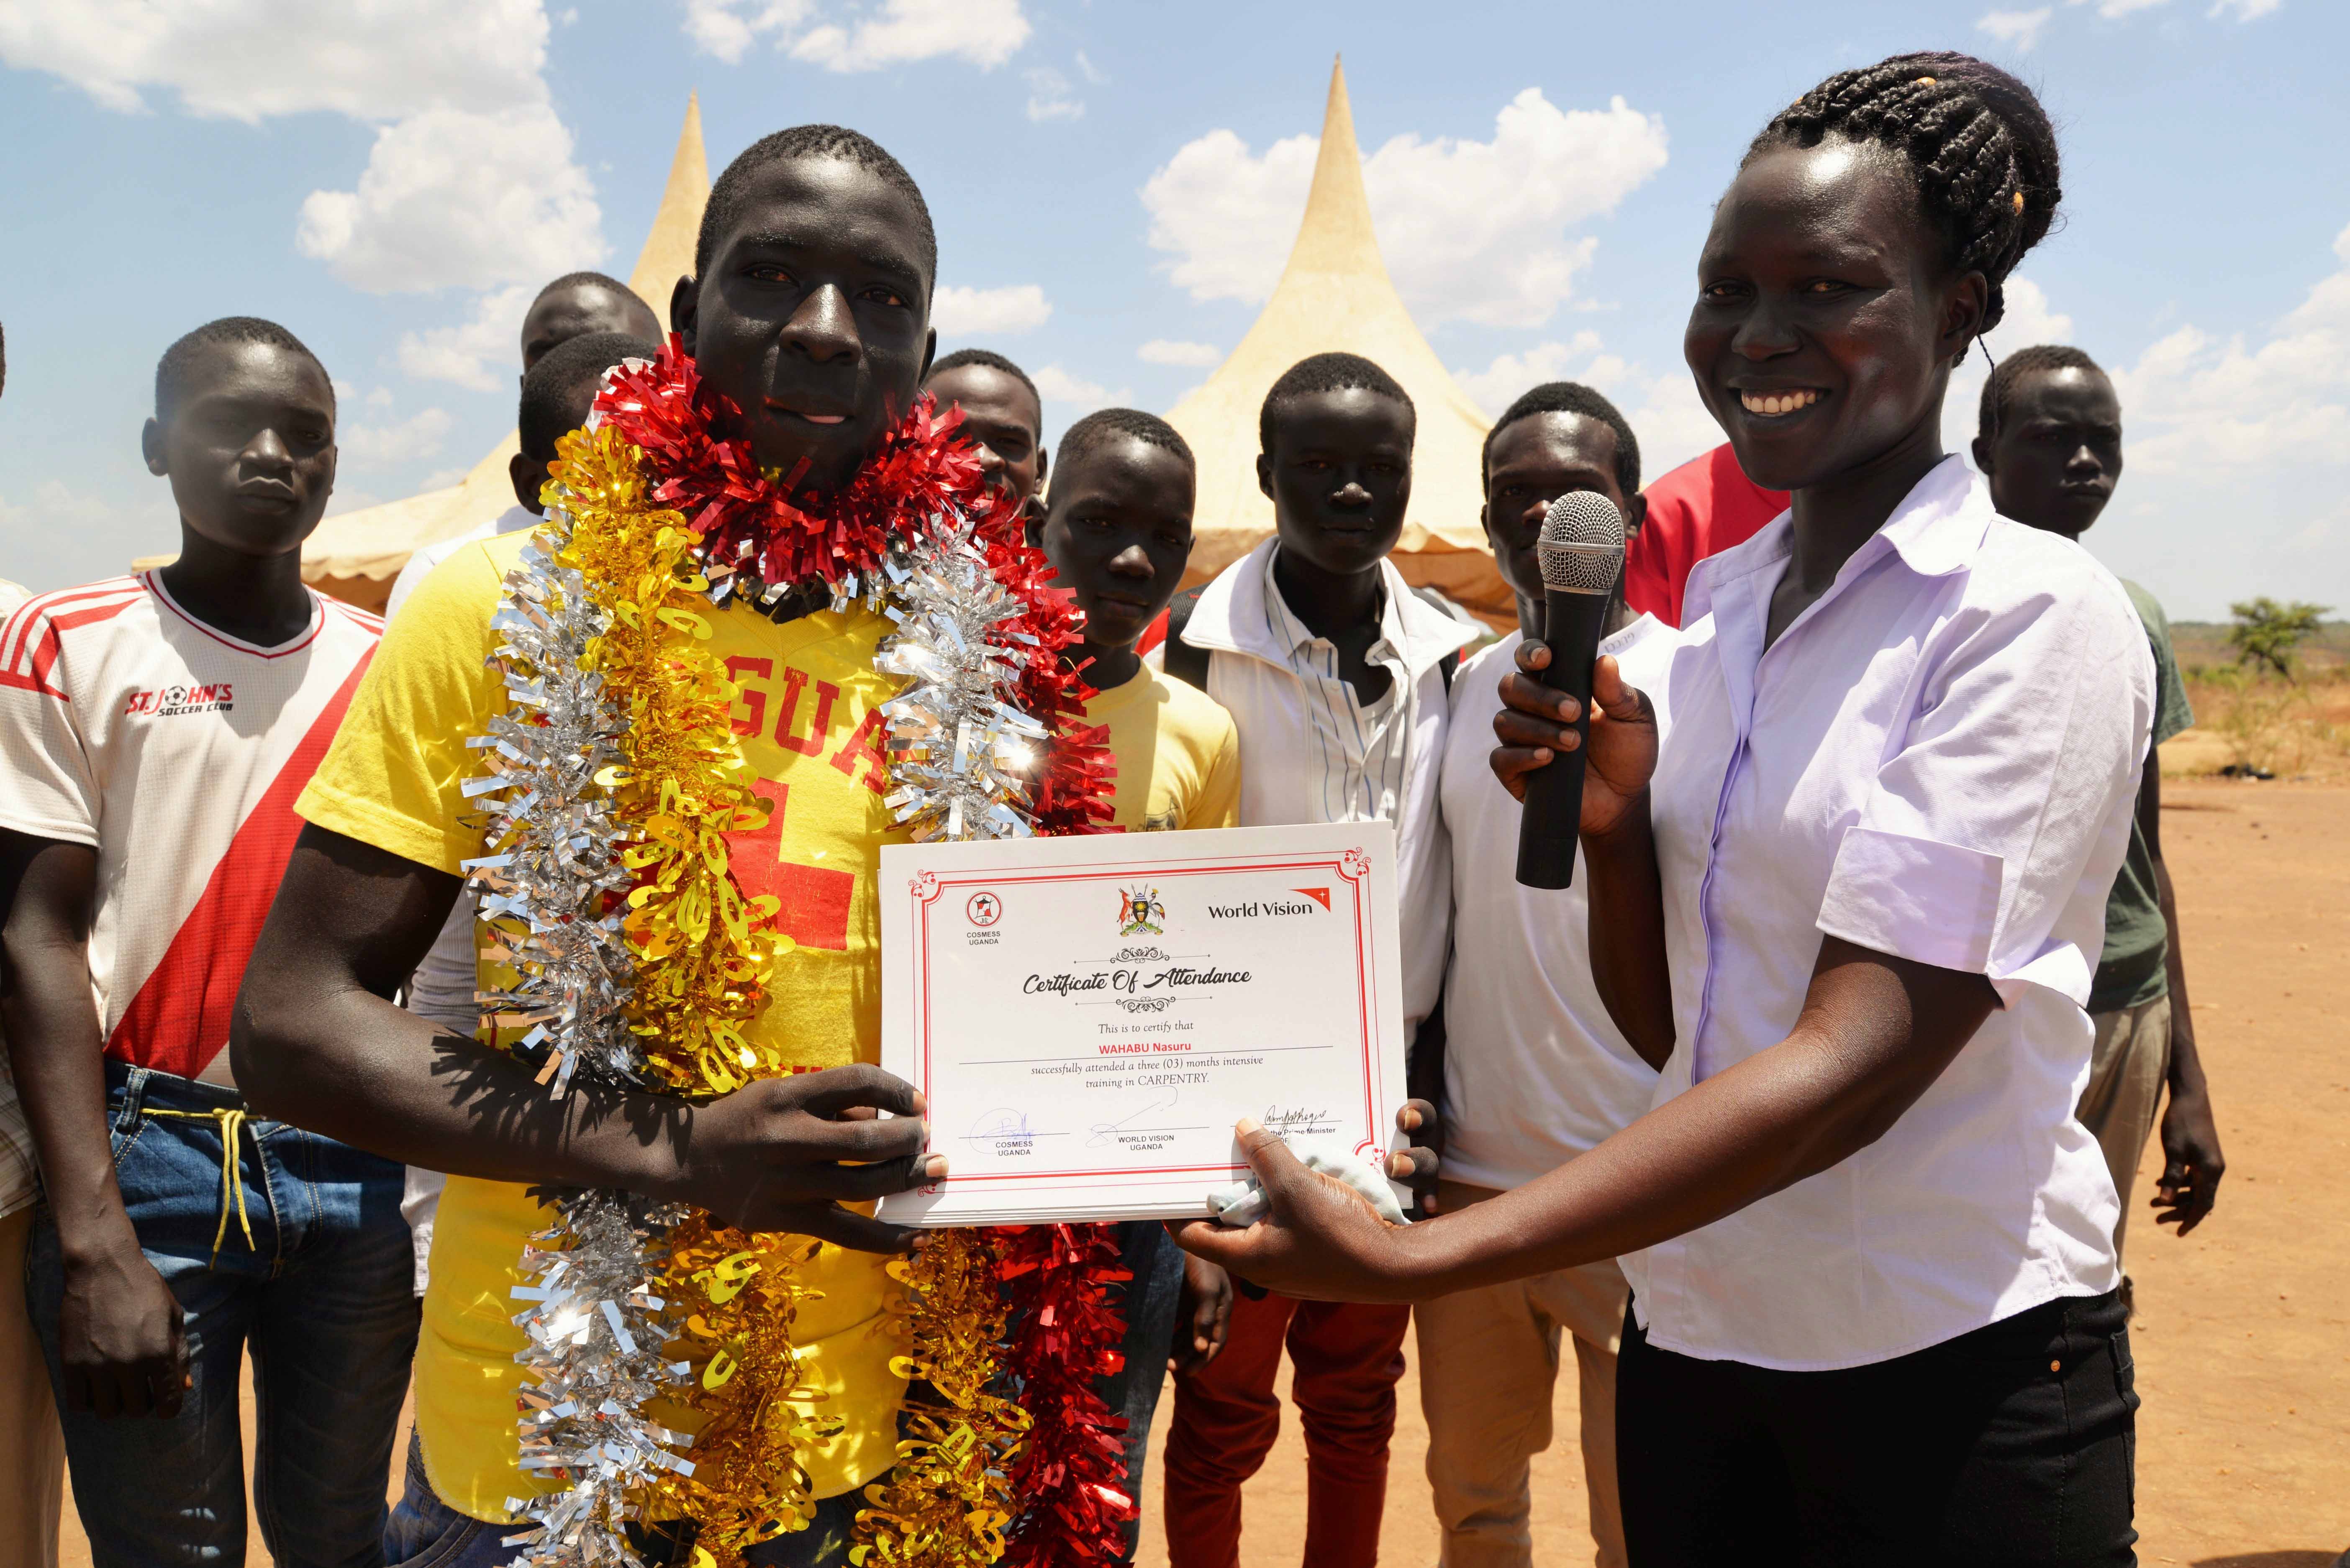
[1029,409,1241,1559]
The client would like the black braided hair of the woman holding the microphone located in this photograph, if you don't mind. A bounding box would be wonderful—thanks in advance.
[1741,49,2063,331]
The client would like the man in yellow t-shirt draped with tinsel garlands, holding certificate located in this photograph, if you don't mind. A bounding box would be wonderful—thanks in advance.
[235,127,945,1568]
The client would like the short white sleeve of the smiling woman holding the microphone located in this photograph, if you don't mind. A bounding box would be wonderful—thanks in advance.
[1819,564,2152,1004]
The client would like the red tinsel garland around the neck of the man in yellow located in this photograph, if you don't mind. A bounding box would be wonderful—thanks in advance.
[597,336,1137,1568]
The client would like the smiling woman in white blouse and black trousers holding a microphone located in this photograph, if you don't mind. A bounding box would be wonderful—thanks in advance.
[1182,54,2152,1568]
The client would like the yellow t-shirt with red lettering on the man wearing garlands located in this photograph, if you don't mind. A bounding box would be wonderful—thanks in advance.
[296,534,907,1523]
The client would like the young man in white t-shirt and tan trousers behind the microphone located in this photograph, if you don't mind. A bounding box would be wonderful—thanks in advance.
[1415,381,1673,1568]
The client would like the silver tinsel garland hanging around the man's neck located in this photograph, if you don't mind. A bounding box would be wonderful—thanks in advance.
[465,484,1050,1568]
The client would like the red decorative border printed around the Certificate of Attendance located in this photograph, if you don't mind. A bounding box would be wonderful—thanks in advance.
[907,846,1386,1192]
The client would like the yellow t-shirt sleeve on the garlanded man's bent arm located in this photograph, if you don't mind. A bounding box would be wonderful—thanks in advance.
[294,546,505,874]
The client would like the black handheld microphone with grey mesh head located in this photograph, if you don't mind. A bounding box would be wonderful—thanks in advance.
[1518,489,1624,889]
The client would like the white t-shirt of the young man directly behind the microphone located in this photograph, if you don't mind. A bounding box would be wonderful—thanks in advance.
[1441,616,1675,1189]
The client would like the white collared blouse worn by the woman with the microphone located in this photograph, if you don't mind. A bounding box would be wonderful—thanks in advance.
[1624,456,2152,1371]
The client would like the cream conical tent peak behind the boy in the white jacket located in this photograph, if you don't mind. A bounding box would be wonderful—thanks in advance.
[1168,64,1516,623]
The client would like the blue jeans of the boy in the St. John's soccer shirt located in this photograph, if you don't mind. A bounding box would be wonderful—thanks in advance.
[26,1063,416,1568]
